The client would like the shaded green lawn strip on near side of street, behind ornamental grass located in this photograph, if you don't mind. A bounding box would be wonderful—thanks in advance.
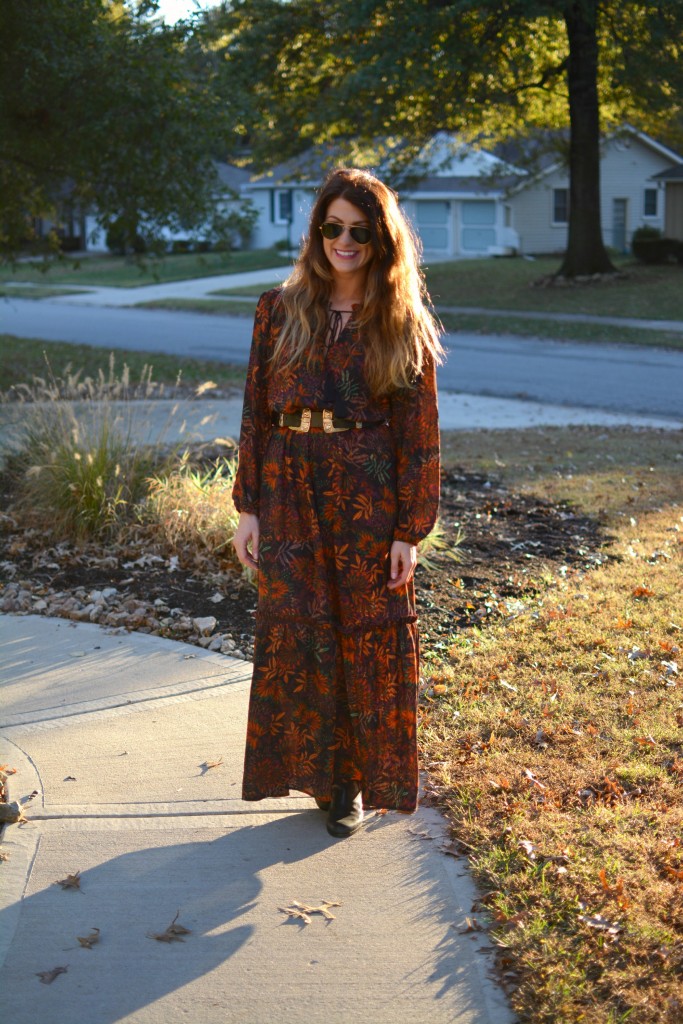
[0,334,247,392]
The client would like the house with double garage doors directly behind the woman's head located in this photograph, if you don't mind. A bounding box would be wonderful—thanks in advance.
[244,133,525,259]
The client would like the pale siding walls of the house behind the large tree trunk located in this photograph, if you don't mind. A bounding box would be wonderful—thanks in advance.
[508,133,672,253]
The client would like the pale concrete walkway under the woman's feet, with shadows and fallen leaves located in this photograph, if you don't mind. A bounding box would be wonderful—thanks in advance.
[0,615,513,1024]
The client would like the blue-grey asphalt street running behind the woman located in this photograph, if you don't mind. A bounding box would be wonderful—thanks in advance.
[0,298,683,418]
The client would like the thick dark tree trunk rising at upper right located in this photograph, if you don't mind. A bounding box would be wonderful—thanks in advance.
[559,0,614,278]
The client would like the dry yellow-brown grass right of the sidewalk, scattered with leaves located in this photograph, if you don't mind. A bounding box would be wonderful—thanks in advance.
[428,428,683,1024]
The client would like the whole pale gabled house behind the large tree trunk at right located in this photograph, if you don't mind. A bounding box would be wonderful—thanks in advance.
[507,126,683,254]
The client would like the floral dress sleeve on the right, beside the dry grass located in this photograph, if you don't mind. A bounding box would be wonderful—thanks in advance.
[391,359,440,544]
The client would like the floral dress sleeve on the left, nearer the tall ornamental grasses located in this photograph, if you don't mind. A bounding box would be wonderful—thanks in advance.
[232,292,273,515]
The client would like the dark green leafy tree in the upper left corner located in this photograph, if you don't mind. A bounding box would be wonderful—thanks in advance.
[0,0,242,256]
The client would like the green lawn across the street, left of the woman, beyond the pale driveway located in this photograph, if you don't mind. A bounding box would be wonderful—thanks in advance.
[0,249,291,288]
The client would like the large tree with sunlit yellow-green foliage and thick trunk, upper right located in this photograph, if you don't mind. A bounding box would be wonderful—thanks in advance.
[212,0,683,275]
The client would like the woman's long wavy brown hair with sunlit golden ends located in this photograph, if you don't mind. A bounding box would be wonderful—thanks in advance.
[272,168,443,395]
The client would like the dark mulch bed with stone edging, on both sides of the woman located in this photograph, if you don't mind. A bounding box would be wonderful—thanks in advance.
[0,470,607,658]
